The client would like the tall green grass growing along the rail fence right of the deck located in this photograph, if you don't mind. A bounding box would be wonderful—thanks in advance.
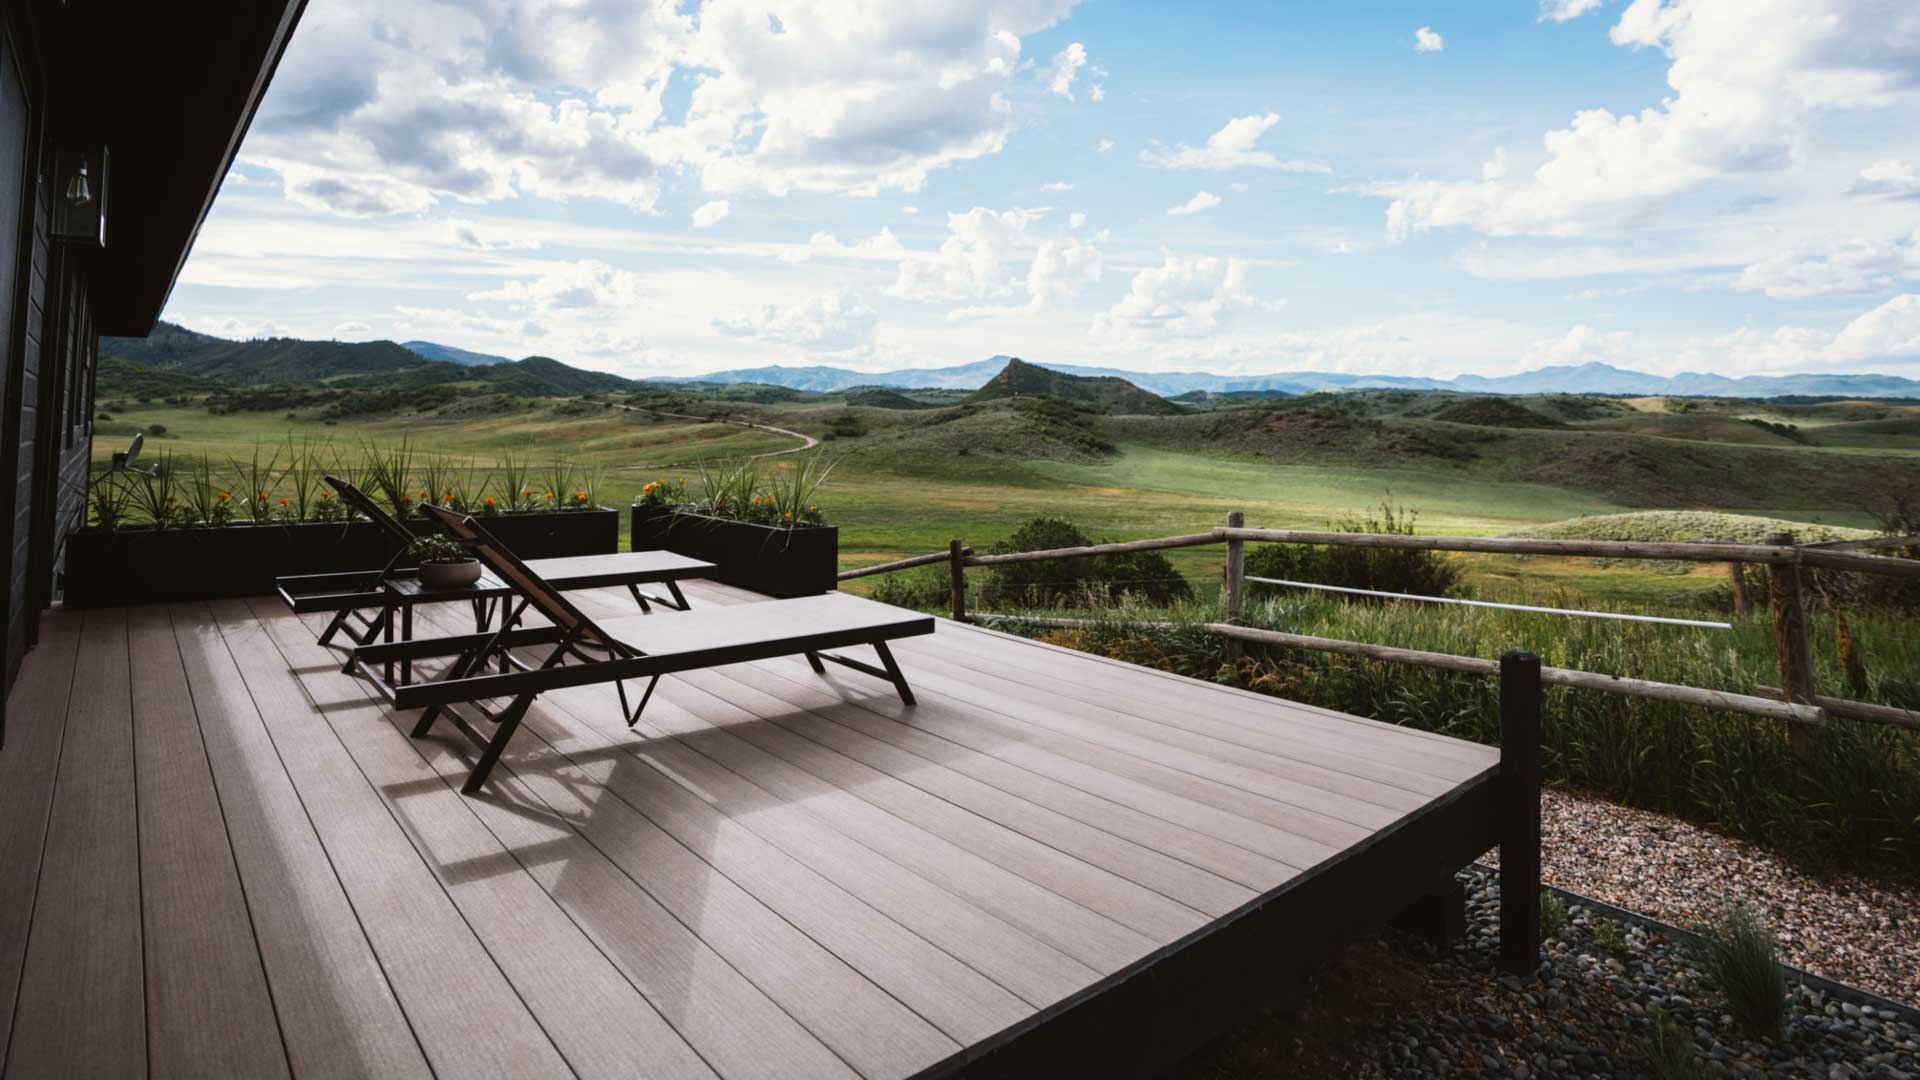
[975,580,1920,880]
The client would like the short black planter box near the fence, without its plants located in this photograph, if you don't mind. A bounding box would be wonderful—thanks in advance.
[634,505,839,598]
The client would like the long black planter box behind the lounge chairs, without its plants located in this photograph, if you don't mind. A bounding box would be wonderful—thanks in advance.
[61,509,620,607]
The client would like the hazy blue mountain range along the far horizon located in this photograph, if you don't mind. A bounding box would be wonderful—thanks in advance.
[653,356,1920,398]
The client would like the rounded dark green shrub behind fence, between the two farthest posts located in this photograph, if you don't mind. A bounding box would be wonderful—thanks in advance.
[981,517,1192,607]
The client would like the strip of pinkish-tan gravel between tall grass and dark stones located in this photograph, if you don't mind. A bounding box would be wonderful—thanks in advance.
[1505,790,1920,1007]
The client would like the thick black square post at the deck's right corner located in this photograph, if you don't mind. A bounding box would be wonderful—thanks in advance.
[1494,650,1542,974]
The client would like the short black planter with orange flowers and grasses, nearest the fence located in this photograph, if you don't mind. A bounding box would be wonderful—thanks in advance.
[634,454,839,598]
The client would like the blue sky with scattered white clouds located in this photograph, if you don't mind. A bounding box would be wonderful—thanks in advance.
[167,0,1920,377]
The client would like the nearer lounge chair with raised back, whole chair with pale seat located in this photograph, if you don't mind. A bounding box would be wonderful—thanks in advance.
[346,507,933,796]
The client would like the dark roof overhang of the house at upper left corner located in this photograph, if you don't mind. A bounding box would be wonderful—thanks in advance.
[35,0,305,336]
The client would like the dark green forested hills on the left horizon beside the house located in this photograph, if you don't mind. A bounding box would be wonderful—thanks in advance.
[100,323,636,398]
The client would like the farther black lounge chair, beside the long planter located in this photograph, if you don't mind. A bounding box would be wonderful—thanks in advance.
[284,477,716,646]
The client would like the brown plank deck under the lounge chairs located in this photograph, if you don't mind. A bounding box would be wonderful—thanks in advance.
[0,582,1500,1080]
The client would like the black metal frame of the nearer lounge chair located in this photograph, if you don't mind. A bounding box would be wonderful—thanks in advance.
[355,507,933,796]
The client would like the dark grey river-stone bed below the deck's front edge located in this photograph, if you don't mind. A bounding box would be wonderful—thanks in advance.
[1173,869,1920,1080]
